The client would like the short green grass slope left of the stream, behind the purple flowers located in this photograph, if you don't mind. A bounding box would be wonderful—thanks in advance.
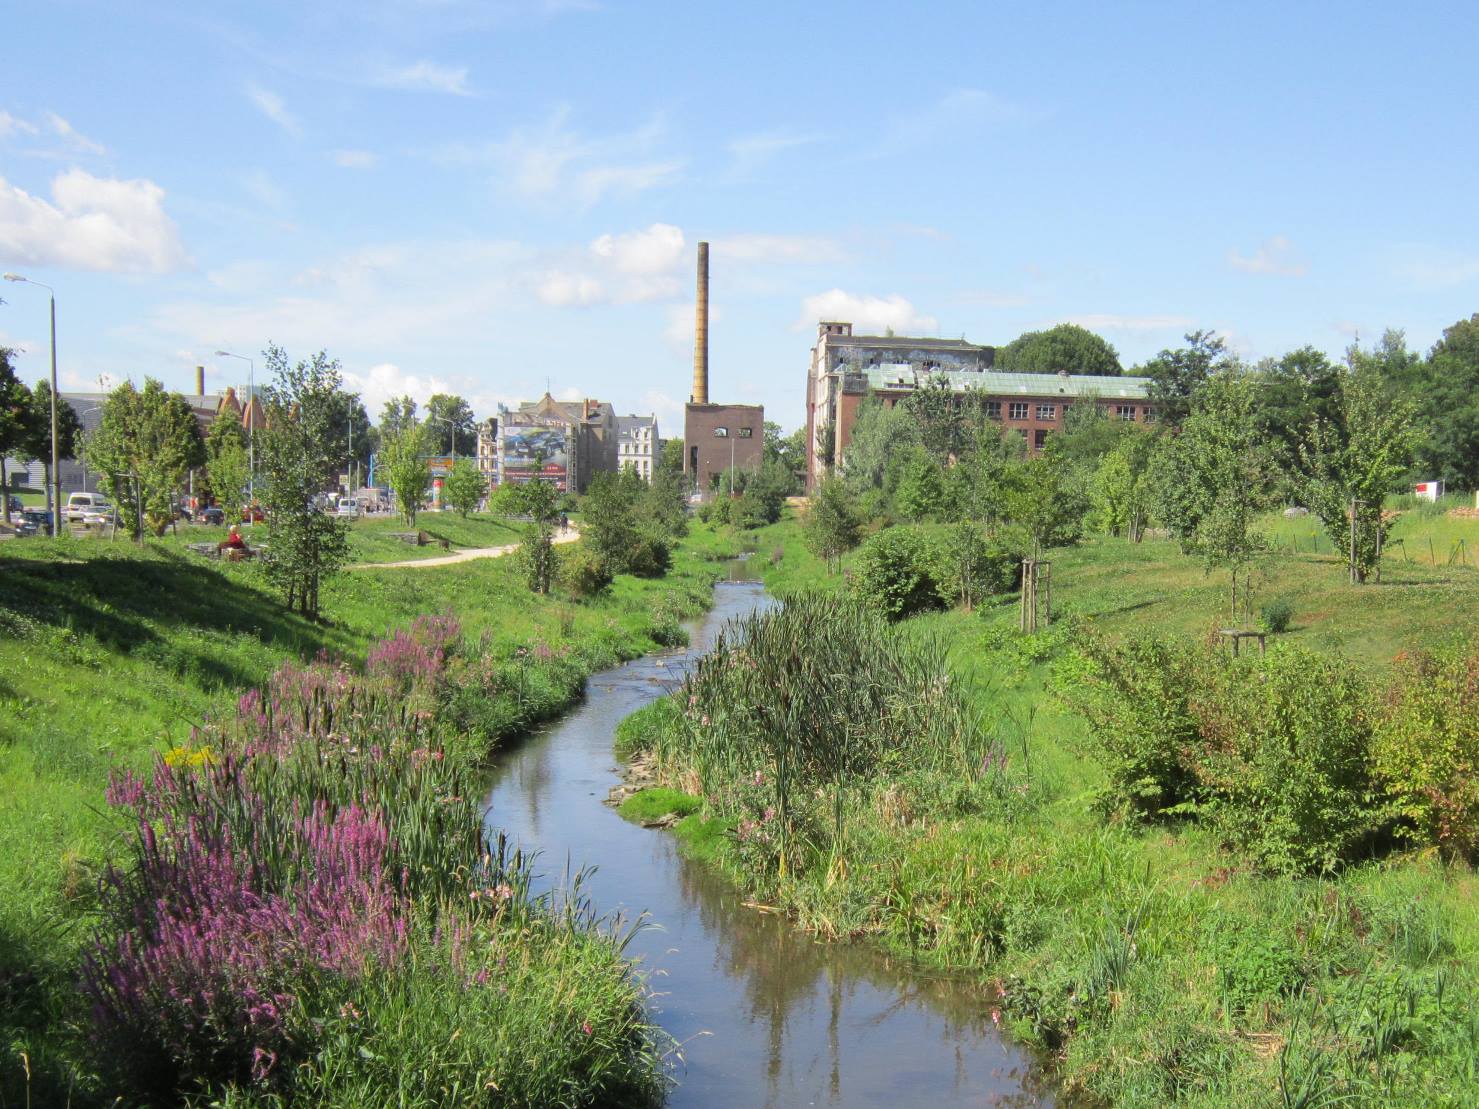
[0,528,723,1105]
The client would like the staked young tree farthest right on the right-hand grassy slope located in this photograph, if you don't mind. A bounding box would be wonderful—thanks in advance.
[1302,371,1418,584]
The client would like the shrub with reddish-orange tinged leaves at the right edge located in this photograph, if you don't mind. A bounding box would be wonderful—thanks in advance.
[1375,640,1479,859]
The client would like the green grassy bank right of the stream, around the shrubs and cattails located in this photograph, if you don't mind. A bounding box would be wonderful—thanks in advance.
[623,522,1479,1106]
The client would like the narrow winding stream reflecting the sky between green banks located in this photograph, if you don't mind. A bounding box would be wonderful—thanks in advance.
[488,584,1050,1109]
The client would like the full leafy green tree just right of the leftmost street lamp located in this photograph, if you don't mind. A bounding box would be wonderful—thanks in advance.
[83,377,204,537]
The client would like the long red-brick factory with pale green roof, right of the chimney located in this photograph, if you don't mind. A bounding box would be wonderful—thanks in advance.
[806,321,1155,485]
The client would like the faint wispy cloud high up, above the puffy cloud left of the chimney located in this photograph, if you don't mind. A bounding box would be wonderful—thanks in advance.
[476,109,685,208]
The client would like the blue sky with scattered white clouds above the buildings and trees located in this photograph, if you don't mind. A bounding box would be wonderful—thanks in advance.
[0,0,1479,432]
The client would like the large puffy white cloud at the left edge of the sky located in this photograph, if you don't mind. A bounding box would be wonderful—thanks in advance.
[0,170,186,274]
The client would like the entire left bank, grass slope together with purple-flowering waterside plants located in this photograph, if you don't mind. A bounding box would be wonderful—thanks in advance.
[0,519,728,1106]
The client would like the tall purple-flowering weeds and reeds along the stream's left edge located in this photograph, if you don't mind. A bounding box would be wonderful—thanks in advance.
[83,618,661,1106]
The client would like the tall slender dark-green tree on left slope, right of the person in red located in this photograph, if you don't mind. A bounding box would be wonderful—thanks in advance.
[257,345,349,617]
